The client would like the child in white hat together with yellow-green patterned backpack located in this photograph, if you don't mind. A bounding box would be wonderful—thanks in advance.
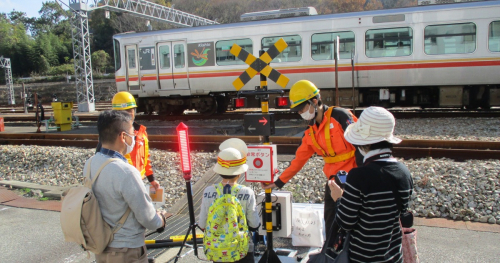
[199,138,260,263]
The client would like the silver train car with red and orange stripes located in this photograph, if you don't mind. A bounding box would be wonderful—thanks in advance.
[114,1,500,114]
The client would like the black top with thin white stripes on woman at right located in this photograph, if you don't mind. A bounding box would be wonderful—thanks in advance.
[337,161,413,262]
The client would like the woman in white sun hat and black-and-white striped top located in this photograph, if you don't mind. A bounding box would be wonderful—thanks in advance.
[329,107,413,262]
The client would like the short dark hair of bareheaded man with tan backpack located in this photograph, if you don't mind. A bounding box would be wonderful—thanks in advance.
[97,110,132,143]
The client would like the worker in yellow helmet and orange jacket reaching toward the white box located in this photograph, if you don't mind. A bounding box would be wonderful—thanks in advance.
[262,80,363,235]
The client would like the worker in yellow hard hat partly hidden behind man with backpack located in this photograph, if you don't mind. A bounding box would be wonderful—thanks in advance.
[96,91,160,189]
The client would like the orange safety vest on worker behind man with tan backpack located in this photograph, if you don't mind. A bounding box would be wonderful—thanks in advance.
[125,125,153,179]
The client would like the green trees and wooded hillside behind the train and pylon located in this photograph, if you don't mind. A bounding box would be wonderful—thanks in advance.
[0,0,417,81]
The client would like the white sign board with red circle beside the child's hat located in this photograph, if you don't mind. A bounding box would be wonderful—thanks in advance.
[245,145,278,183]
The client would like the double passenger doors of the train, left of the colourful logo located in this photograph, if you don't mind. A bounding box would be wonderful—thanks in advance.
[157,41,189,90]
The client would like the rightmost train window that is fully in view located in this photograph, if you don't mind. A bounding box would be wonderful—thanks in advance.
[424,23,476,55]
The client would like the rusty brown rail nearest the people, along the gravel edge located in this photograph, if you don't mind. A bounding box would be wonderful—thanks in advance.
[0,133,500,161]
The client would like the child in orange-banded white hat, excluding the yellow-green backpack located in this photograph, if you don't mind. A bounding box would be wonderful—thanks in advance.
[198,138,260,263]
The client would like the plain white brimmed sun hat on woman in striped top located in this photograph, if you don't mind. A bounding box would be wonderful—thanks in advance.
[344,107,401,145]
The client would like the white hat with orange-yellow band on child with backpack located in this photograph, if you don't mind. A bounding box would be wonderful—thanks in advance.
[214,148,248,176]
